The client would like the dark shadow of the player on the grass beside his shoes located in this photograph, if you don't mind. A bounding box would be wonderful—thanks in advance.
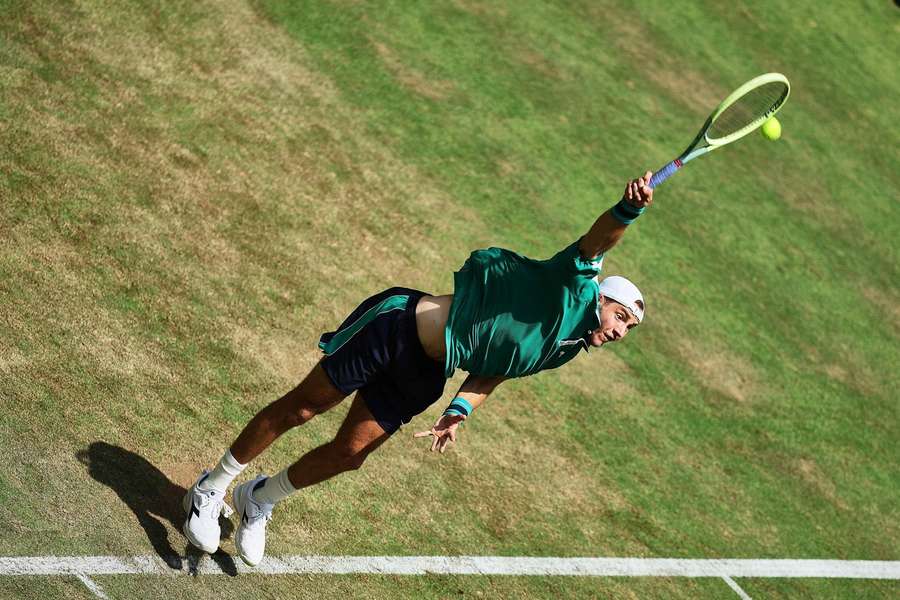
[77,442,237,575]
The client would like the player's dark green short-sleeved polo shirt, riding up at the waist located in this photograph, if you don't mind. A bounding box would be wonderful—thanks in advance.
[444,242,603,378]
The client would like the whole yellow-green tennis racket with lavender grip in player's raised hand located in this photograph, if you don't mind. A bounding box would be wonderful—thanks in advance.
[649,73,791,188]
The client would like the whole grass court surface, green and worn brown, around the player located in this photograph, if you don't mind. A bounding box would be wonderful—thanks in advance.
[0,0,900,598]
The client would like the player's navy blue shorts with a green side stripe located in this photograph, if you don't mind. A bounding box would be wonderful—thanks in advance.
[319,288,447,433]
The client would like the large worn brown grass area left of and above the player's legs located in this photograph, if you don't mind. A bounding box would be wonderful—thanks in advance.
[0,3,487,551]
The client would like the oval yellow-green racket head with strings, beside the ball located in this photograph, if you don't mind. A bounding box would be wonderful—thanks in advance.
[703,73,791,146]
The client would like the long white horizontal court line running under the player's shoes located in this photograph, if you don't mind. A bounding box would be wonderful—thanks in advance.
[0,555,900,579]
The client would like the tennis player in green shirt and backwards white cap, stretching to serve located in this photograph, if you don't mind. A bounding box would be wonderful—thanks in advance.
[183,172,653,565]
